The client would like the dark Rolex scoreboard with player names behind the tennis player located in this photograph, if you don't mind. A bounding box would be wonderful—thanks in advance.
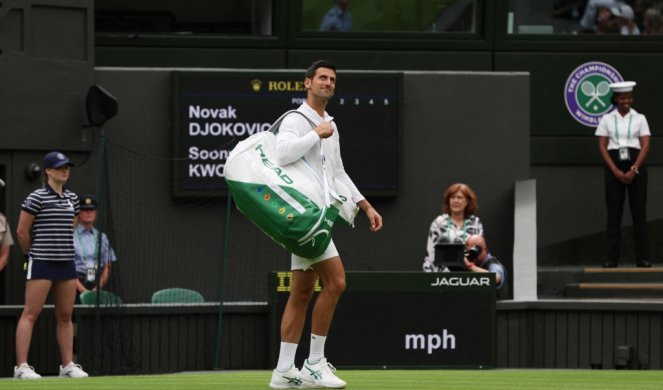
[173,70,403,196]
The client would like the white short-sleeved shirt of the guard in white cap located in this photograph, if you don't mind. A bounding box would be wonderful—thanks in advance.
[595,108,651,150]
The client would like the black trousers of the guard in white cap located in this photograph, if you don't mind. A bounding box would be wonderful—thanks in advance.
[605,149,649,262]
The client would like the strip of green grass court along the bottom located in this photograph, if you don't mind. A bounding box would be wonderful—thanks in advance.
[0,369,663,390]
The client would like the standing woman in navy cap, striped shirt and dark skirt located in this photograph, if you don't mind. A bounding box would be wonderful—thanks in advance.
[14,152,88,379]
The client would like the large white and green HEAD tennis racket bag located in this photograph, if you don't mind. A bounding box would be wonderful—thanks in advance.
[224,110,358,259]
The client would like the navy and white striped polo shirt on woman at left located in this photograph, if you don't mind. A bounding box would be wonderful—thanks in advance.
[21,184,79,261]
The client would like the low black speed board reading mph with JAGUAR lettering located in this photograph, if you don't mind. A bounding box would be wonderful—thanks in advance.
[268,271,496,368]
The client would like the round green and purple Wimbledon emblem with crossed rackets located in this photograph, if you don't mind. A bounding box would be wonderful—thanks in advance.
[564,61,624,127]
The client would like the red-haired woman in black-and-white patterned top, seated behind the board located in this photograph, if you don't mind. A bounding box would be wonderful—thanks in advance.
[423,183,483,272]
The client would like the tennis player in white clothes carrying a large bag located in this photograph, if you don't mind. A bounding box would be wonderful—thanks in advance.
[269,60,382,389]
